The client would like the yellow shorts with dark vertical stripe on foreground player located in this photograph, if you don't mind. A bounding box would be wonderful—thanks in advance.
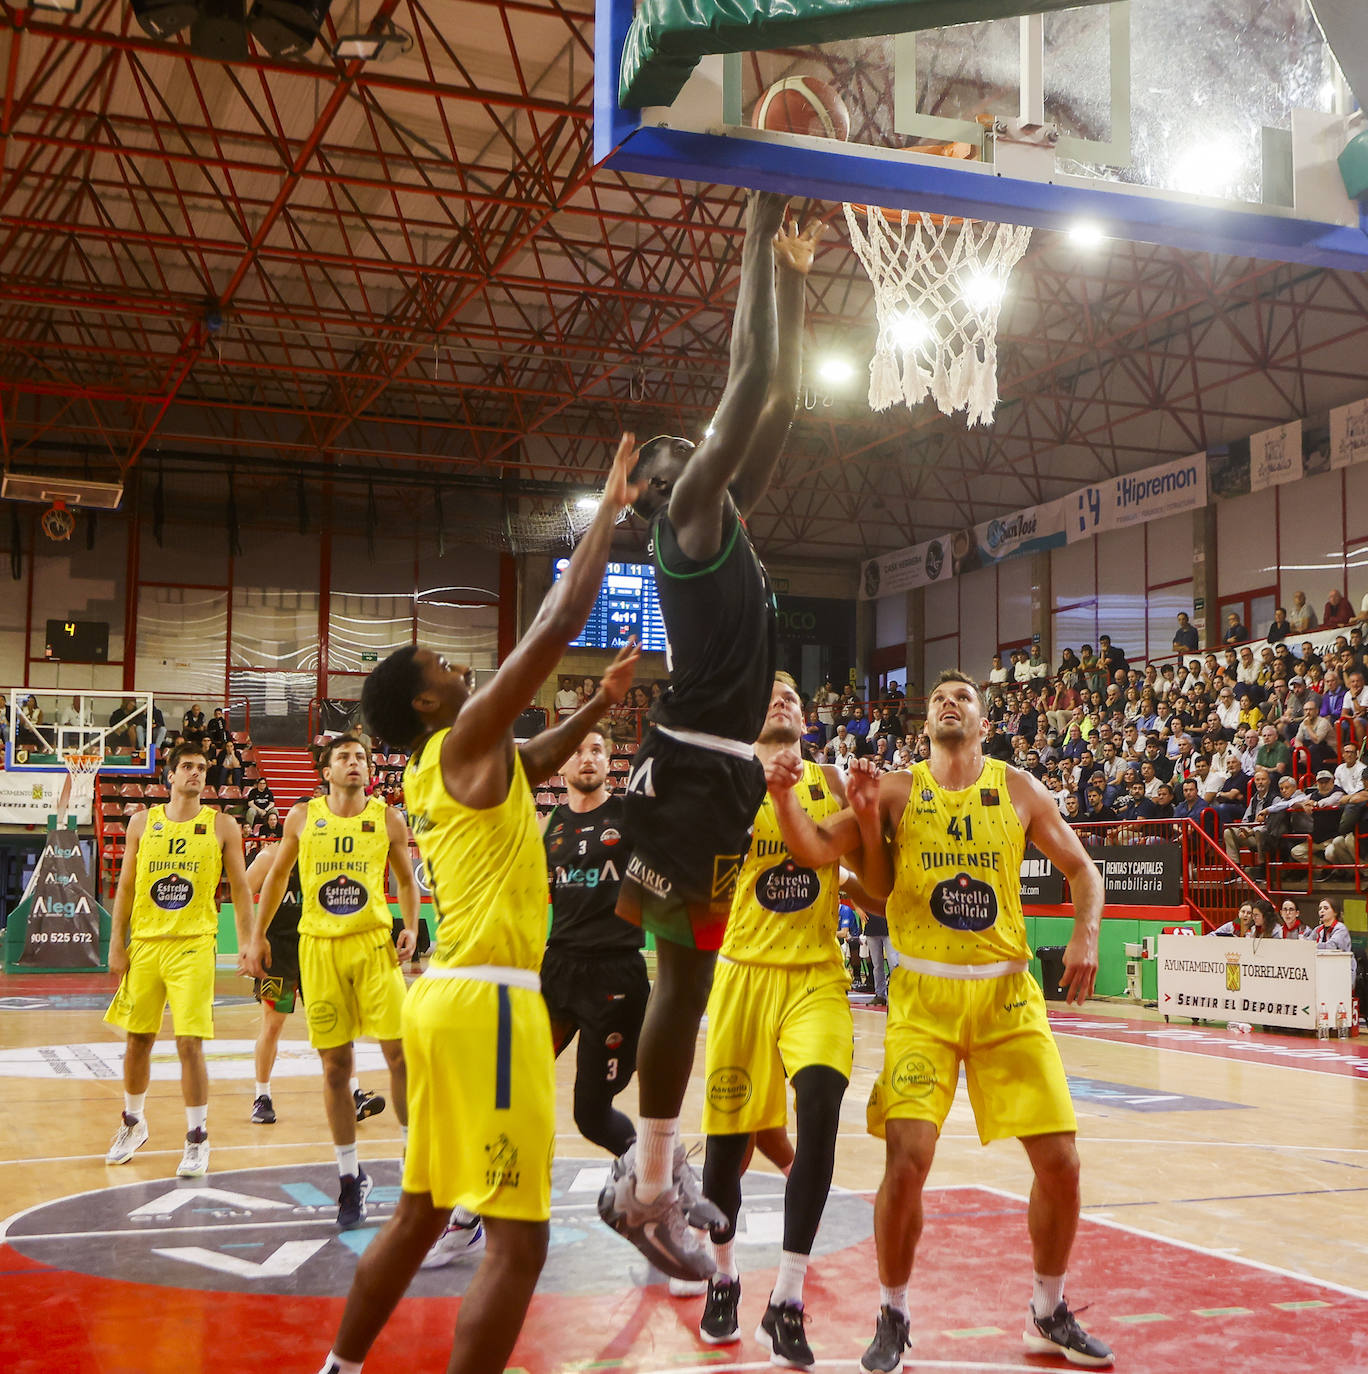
[404,976,556,1221]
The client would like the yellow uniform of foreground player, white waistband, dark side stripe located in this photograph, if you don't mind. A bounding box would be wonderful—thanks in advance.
[398,730,556,1221]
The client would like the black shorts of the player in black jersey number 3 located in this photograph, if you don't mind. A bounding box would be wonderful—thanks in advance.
[541,949,651,1092]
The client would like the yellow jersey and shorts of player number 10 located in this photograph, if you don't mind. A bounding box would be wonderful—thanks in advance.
[298,797,404,1050]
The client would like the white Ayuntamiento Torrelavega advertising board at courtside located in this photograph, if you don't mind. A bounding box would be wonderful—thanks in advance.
[1159,936,1353,1031]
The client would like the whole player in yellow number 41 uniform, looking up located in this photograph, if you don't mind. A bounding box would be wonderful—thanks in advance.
[769,671,1113,1370]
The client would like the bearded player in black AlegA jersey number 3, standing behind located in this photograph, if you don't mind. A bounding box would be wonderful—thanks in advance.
[541,730,651,1156]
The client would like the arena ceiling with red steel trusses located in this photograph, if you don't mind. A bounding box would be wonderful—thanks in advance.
[0,0,1368,561]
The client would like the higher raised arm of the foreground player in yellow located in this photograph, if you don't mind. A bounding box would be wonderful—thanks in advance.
[442,434,640,769]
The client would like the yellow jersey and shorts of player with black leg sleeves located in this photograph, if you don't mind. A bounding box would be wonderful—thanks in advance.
[703,763,854,1135]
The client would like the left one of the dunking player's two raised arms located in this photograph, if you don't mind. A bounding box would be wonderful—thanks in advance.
[670,191,797,561]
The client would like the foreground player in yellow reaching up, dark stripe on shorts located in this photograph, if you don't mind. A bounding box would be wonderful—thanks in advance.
[315,434,637,1374]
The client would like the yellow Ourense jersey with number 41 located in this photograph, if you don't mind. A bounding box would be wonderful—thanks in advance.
[889,758,1030,965]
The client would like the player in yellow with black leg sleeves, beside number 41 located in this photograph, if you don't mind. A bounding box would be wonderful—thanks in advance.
[699,673,854,1369]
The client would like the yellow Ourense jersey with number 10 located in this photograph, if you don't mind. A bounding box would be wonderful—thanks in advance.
[299,797,393,940]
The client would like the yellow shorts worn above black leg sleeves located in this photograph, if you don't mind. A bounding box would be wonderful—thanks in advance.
[703,960,854,1135]
